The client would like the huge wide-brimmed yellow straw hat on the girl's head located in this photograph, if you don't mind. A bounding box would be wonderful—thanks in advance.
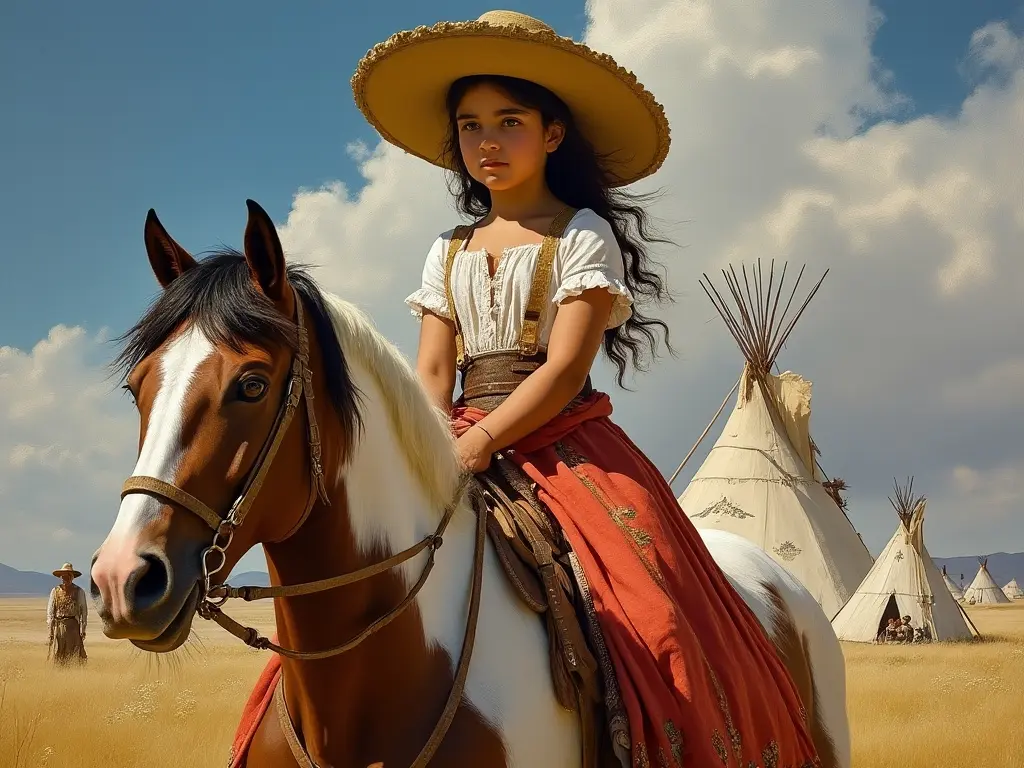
[352,10,669,186]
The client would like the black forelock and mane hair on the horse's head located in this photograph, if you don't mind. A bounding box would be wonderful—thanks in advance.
[112,248,361,440]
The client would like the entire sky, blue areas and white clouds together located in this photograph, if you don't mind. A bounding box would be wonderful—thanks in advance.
[0,0,1024,579]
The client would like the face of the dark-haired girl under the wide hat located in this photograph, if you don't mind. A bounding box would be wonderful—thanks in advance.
[456,84,565,191]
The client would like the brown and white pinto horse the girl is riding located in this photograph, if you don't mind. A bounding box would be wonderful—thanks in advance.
[90,201,850,768]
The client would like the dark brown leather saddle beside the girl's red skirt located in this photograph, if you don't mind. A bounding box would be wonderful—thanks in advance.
[476,455,628,768]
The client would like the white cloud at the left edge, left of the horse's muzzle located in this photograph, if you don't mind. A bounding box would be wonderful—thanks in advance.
[0,326,137,569]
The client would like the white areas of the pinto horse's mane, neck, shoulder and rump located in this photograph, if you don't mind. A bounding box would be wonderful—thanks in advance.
[309,296,850,768]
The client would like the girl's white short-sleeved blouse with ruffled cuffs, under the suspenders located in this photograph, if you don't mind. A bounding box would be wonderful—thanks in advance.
[406,208,633,357]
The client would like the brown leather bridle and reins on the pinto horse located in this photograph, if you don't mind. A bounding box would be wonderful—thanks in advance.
[121,287,486,768]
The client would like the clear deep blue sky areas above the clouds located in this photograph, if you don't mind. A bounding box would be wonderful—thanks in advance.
[0,0,1024,348]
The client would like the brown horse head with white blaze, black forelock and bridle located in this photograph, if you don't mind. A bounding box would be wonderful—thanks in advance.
[91,201,358,651]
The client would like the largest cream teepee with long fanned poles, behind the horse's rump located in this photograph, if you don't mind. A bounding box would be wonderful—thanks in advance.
[673,260,871,618]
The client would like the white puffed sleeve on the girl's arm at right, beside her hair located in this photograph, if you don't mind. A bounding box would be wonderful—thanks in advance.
[551,209,633,329]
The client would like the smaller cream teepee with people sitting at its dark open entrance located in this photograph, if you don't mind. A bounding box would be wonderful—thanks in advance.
[833,478,977,643]
